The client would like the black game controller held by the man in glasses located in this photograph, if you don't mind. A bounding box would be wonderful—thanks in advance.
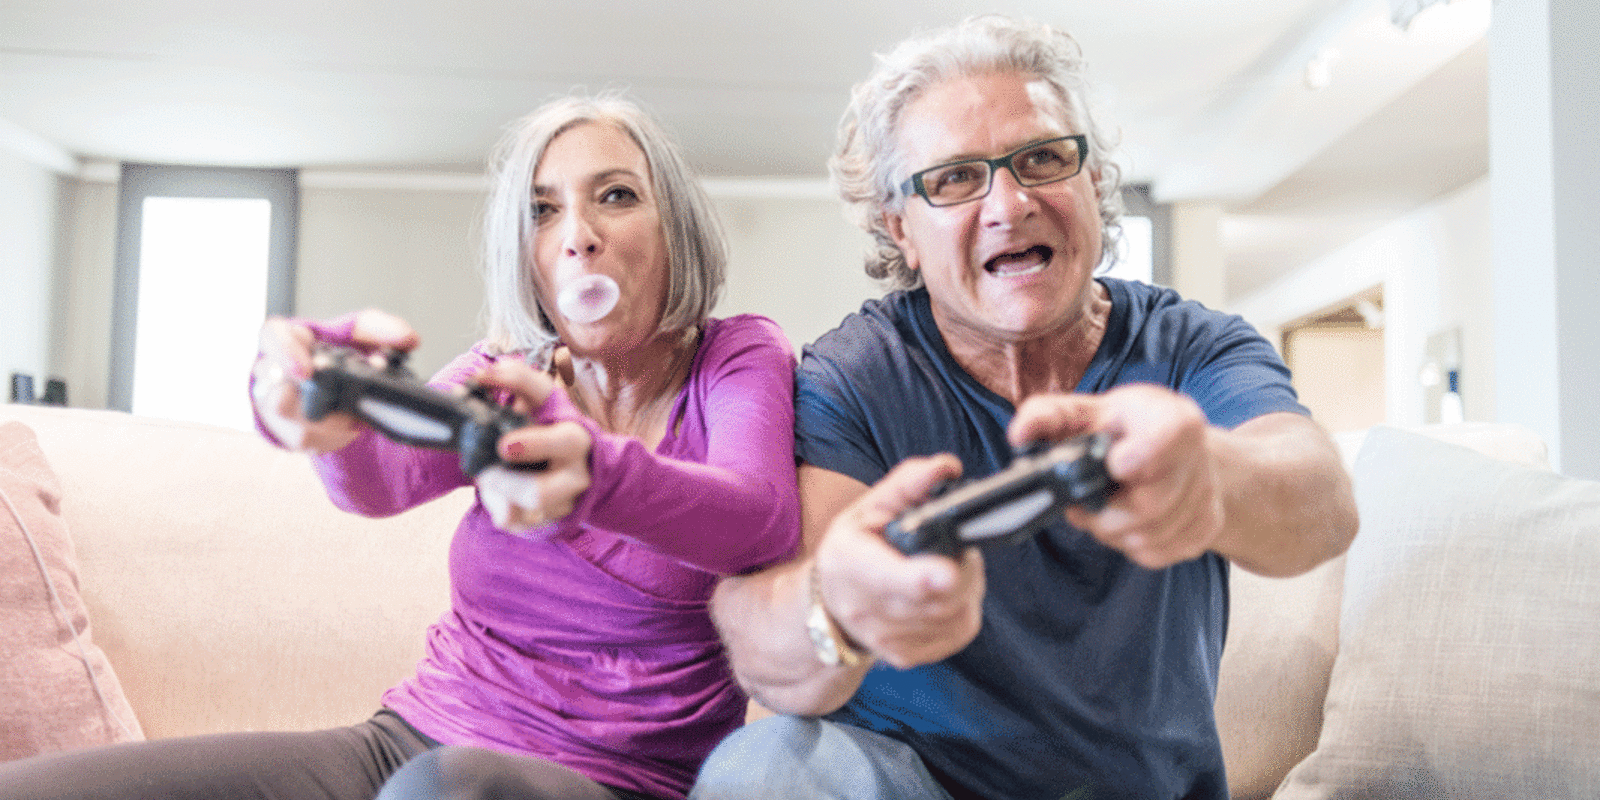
[883,434,1117,557]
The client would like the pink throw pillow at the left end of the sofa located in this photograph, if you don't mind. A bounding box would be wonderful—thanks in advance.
[0,422,141,762]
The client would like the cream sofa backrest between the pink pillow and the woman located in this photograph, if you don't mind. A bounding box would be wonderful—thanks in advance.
[0,406,472,739]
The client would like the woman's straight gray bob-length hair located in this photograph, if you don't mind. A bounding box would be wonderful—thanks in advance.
[483,94,728,354]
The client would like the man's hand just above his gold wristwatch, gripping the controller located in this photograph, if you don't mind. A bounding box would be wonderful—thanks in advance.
[814,454,984,669]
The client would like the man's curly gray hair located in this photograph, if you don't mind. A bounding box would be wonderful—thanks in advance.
[827,14,1122,290]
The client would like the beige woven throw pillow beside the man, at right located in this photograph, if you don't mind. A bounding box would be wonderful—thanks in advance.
[1275,427,1600,800]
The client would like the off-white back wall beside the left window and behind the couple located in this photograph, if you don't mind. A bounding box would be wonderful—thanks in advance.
[37,173,882,408]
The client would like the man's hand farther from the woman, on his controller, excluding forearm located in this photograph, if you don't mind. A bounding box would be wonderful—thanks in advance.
[1008,384,1227,570]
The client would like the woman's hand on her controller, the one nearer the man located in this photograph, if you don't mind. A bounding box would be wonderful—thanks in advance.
[477,358,594,533]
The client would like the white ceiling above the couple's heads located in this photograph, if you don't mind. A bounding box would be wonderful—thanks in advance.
[0,0,1490,296]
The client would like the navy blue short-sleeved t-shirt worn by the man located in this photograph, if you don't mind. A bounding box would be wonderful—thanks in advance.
[795,278,1306,800]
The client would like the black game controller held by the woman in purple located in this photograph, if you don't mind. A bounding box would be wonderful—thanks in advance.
[301,347,542,478]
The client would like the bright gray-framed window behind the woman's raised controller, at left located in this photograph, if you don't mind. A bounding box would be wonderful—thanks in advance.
[107,163,299,430]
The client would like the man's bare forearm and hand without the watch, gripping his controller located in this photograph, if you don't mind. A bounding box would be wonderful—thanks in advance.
[1006,384,1358,578]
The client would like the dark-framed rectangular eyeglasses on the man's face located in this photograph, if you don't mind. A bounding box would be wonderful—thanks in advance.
[901,133,1090,206]
